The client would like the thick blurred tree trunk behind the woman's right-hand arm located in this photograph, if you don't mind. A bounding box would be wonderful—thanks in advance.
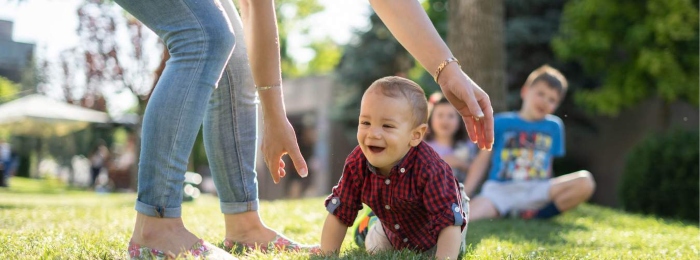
[447,0,507,112]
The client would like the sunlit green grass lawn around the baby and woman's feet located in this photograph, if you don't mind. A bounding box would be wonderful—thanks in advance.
[0,178,700,259]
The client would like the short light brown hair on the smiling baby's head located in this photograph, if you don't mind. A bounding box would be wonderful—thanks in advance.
[365,76,428,127]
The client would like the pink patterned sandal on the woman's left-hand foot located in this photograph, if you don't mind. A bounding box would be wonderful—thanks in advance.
[129,239,236,260]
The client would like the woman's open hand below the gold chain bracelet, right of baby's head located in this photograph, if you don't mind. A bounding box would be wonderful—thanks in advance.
[438,62,493,150]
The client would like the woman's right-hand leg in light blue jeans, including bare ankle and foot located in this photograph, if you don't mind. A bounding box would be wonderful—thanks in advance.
[204,1,292,244]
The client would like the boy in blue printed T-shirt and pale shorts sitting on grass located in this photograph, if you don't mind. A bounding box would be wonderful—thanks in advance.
[465,65,595,221]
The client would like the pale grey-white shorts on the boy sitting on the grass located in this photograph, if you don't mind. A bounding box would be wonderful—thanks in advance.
[478,180,551,216]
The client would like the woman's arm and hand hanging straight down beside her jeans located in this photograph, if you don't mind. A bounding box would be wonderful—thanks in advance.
[240,0,308,183]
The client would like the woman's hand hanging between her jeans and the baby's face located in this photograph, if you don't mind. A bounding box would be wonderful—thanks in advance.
[261,115,309,183]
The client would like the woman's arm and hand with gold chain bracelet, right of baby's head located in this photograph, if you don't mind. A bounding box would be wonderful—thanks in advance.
[370,0,493,149]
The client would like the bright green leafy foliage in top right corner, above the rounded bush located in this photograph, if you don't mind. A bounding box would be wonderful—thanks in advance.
[552,0,699,115]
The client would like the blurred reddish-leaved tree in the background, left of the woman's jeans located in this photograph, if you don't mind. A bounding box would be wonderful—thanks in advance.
[44,0,159,115]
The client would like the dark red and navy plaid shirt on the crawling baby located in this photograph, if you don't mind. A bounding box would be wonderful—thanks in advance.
[325,142,466,251]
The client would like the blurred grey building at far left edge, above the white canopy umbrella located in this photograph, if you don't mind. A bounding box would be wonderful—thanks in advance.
[0,20,34,82]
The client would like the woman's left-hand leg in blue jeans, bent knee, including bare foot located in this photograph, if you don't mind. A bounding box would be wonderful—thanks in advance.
[116,0,235,252]
